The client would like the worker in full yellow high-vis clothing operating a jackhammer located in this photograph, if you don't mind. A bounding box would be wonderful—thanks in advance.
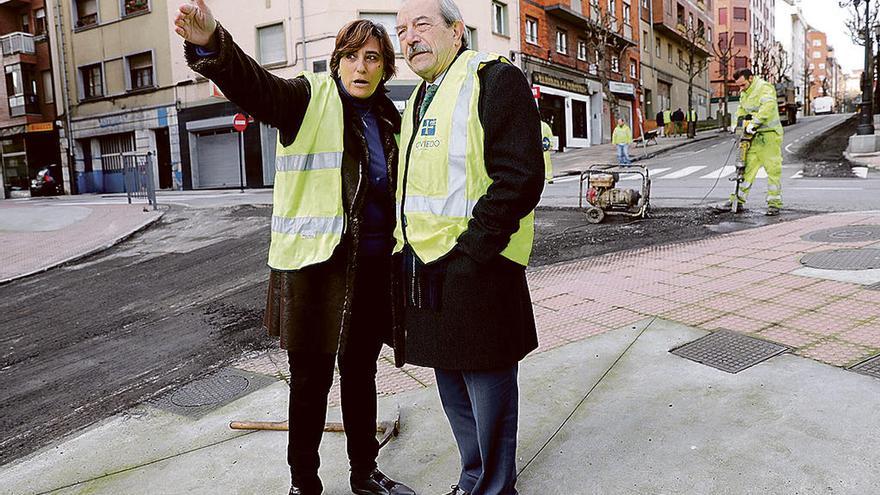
[729,69,782,216]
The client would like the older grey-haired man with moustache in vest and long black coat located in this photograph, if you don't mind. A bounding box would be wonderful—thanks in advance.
[395,0,543,495]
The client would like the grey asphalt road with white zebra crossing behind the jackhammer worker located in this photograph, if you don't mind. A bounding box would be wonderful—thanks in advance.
[541,115,880,211]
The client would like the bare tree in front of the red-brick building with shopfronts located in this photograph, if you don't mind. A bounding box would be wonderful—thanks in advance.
[584,0,633,140]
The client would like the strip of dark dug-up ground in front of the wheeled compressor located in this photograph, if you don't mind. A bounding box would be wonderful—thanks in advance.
[530,207,815,266]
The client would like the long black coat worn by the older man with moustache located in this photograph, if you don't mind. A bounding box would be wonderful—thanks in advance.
[395,58,544,370]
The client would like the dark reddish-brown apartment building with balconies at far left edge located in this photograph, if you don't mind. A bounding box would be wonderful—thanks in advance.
[0,0,65,199]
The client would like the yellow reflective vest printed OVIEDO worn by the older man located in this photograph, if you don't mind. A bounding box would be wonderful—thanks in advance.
[394,50,535,266]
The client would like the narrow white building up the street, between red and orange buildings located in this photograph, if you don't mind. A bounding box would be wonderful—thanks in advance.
[775,0,809,113]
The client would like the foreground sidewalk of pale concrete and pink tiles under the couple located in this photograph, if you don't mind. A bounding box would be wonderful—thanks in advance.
[0,212,880,495]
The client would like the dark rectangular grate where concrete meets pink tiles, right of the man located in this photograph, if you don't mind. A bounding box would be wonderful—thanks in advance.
[669,330,791,373]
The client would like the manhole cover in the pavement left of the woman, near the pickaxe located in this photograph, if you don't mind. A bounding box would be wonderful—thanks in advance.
[149,368,276,416]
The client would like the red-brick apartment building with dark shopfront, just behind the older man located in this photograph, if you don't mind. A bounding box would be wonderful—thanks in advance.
[520,0,641,149]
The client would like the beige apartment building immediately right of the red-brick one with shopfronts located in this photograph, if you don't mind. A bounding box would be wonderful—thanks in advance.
[640,0,715,119]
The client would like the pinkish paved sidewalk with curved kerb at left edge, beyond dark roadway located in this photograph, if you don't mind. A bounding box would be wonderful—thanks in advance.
[0,198,163,284]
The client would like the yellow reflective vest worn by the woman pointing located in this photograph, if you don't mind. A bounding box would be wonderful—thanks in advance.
[269,72,345,270]
